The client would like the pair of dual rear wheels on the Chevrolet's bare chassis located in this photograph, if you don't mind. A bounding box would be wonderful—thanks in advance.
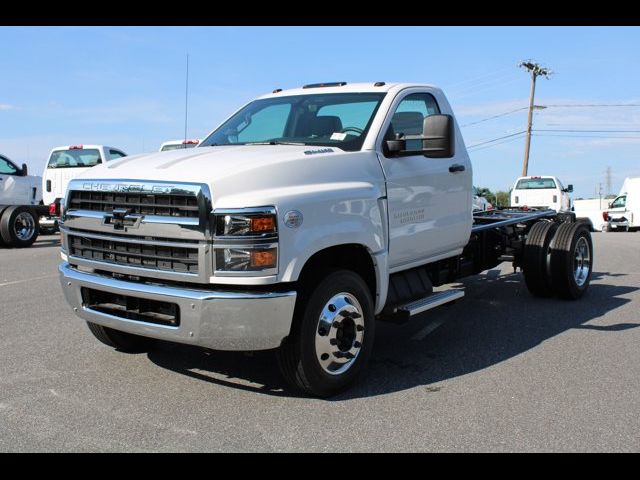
[522,221,593,300]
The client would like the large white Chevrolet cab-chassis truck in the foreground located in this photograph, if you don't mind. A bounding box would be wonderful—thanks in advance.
[59,82,593,397]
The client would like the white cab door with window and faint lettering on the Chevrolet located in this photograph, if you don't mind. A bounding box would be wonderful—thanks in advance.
[379,89,472,270]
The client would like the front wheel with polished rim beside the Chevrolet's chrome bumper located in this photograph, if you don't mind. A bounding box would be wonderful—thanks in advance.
[278,270,375,397]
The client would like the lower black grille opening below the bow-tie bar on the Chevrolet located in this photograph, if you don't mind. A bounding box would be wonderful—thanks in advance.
[69,235,198,274]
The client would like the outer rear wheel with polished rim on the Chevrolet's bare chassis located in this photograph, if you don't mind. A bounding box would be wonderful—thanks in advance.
[551,223,593,300]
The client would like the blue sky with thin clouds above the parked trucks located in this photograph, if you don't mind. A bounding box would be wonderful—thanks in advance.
[0,27,640,198]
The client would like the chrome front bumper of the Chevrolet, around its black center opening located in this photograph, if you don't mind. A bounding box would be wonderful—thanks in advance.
[58,262,296,351]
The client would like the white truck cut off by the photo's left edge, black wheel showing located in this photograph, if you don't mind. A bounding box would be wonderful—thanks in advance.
[0,155,46,247]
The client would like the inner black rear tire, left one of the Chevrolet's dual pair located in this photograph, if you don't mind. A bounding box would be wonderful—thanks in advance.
[522,222,558,297]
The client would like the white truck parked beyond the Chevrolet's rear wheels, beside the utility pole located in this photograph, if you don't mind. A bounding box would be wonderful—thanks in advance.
[511,176,573,212]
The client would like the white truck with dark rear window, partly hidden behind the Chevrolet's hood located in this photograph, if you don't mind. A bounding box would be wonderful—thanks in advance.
[40,145,127,229]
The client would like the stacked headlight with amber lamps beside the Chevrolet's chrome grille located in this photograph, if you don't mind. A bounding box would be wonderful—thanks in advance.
[213,207,278,276]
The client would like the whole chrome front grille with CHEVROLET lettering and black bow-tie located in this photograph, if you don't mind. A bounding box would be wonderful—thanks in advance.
[60,179,213,283]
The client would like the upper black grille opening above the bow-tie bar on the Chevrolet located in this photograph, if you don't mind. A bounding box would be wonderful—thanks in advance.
[69,190,200,218]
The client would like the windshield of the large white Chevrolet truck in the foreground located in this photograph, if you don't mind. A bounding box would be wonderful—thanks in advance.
[201,93,385,151]
